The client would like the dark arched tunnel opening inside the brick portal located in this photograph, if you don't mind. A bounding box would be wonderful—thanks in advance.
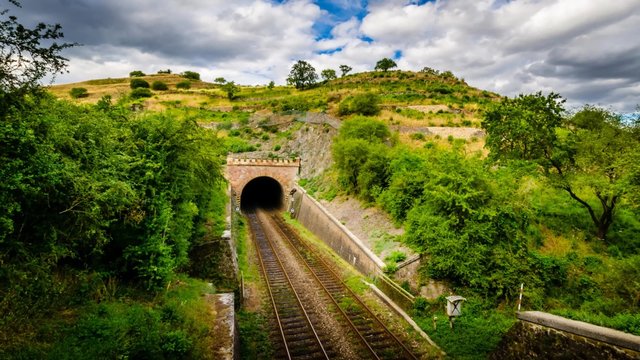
[240,176,284,211]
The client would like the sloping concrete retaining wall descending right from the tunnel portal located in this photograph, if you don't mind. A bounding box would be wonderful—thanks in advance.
[287,186,384,276]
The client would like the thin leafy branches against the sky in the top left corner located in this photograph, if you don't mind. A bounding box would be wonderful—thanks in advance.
[0,0,77,95]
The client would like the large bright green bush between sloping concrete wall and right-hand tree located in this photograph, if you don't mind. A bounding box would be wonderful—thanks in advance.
[405,151,530,299]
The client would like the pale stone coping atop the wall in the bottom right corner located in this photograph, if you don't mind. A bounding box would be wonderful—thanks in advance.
[516,311,640,352]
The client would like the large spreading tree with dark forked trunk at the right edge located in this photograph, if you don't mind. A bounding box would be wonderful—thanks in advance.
[482,92,640,240]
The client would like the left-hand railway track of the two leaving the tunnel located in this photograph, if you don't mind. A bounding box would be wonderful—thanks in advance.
[246,213,332,359]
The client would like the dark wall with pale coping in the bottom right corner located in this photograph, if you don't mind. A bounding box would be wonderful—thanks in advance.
[490,311,640,360]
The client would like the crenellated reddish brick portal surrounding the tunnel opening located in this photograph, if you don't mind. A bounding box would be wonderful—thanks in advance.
[225,157,300,210]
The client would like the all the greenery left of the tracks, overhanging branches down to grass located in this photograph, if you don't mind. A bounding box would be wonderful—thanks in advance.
[0,1,235,359]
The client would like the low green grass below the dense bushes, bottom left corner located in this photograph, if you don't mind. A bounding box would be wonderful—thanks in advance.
[0,277,215,359]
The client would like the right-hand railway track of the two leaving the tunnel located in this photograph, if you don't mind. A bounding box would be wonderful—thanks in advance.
[269,214,416,359]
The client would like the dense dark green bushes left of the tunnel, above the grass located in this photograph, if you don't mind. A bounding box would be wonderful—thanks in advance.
[0,98,221,295]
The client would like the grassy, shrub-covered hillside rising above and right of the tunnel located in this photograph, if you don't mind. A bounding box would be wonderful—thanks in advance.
[42,71,640,357]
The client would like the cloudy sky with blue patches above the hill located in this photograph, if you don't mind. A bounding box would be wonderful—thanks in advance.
[6,0,640,112]
